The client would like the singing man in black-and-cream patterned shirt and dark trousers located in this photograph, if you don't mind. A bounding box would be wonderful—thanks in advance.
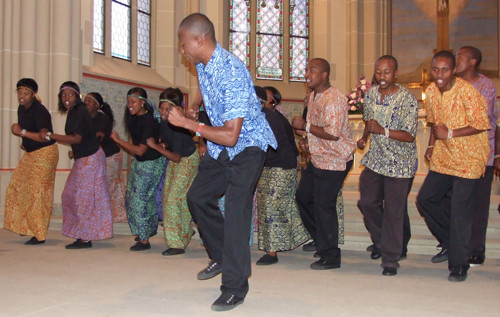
[358,55,417,276]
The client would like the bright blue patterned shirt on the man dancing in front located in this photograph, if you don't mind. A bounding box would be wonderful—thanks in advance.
[196,43,278,160]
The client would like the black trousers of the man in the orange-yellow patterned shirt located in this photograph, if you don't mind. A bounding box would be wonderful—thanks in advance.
[417,171,478,270]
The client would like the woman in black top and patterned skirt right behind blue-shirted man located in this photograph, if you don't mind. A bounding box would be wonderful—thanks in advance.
[255,87,310,265]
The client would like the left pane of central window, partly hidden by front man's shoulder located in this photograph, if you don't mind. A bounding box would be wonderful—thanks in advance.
[229,0,250,67]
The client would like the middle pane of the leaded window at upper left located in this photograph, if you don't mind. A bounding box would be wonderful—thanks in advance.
[111,0,131,60]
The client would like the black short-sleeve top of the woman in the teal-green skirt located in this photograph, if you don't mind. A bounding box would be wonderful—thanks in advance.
[129,113,161,162]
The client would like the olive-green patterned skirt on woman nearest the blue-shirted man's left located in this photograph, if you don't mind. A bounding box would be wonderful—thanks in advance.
[162,151,200,249]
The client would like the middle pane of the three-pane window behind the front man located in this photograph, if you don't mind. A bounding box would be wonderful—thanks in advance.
[256,0,283,80]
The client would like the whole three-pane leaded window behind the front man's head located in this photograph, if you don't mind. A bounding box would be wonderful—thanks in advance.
[229,0,309,81]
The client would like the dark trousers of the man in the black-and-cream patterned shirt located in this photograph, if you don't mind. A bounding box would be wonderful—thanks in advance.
[358,168,413,268]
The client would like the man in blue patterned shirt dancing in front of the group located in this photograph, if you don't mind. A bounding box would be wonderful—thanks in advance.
[168,13,277,311]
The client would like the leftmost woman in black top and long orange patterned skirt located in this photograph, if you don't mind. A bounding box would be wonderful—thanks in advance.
[3,78,59,245]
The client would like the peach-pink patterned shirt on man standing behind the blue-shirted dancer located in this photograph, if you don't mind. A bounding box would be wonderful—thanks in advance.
[307,86,356,171]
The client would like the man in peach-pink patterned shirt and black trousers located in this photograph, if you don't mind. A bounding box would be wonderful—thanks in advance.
[292,58,356,270]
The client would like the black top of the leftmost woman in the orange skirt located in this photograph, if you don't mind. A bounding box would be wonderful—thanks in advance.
[17,100,56,152]
